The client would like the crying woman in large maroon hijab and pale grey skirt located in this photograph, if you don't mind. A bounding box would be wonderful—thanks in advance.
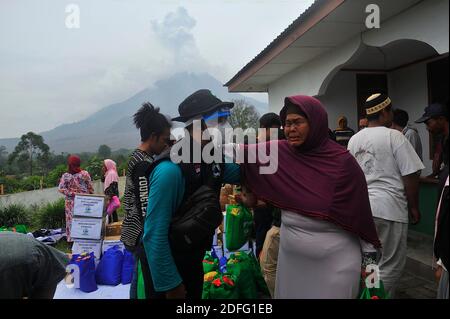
[241,96,380,298]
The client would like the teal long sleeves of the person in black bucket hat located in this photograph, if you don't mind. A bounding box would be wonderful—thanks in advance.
[143,161,240,292]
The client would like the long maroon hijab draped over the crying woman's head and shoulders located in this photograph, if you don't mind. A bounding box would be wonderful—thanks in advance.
[241,95,381,247]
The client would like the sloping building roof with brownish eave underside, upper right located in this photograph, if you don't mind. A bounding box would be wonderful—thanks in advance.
[225,0,421,92]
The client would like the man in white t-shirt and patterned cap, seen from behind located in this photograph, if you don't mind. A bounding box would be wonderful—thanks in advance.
[348,93,424,298]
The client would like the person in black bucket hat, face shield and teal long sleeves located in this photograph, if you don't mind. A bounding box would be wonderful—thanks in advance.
[143,90,240,299]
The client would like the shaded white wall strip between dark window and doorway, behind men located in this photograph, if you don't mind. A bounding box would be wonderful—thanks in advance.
[388,63,432,176]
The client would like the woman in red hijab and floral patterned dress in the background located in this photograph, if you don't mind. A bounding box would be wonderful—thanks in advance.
[58,155,94,242]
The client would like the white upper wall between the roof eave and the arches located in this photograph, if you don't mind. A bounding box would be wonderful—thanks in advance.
[268,0,449,112]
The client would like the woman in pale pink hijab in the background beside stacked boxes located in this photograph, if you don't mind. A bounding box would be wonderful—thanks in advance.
[103,159,120,223]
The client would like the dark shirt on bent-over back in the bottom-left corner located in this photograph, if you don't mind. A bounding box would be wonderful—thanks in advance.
[0,232,69,299]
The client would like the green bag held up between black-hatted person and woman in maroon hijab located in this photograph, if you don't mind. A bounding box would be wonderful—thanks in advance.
[225,205,253,251]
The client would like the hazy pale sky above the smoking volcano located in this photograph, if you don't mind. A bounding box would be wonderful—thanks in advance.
[0,0,313,138]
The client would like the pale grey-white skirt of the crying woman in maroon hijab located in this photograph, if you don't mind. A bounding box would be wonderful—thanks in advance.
[275,211,361,299]
